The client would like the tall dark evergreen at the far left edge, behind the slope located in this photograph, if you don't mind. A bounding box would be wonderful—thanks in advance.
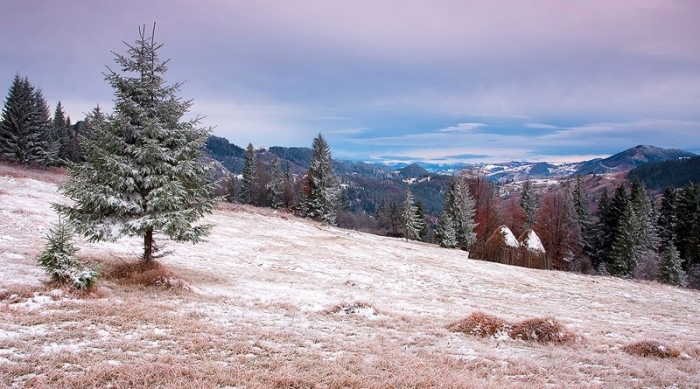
[0,74,57,164]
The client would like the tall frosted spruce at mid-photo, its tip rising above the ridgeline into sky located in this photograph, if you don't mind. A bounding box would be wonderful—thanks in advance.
[304,134,339,225]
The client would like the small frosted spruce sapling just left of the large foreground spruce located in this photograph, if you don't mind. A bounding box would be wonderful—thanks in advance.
[39,220,100,290]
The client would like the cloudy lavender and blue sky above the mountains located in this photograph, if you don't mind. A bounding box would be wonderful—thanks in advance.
[0,0,700,163]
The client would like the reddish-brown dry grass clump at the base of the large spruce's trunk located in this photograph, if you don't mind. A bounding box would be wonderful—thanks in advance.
[103,261,185,289]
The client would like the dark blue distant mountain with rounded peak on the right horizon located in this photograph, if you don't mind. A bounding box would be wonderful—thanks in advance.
[575,145,696,175]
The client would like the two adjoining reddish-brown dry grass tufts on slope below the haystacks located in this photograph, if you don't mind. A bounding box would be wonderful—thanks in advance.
[447,311,576,343]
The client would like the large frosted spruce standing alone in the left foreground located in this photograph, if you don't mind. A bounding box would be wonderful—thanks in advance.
[55,25,216,262]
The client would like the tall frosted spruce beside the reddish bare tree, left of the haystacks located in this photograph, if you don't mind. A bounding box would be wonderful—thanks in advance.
[444,176,476,250]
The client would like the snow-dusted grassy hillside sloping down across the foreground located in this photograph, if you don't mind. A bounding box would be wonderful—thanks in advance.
[0,164,700,388]
